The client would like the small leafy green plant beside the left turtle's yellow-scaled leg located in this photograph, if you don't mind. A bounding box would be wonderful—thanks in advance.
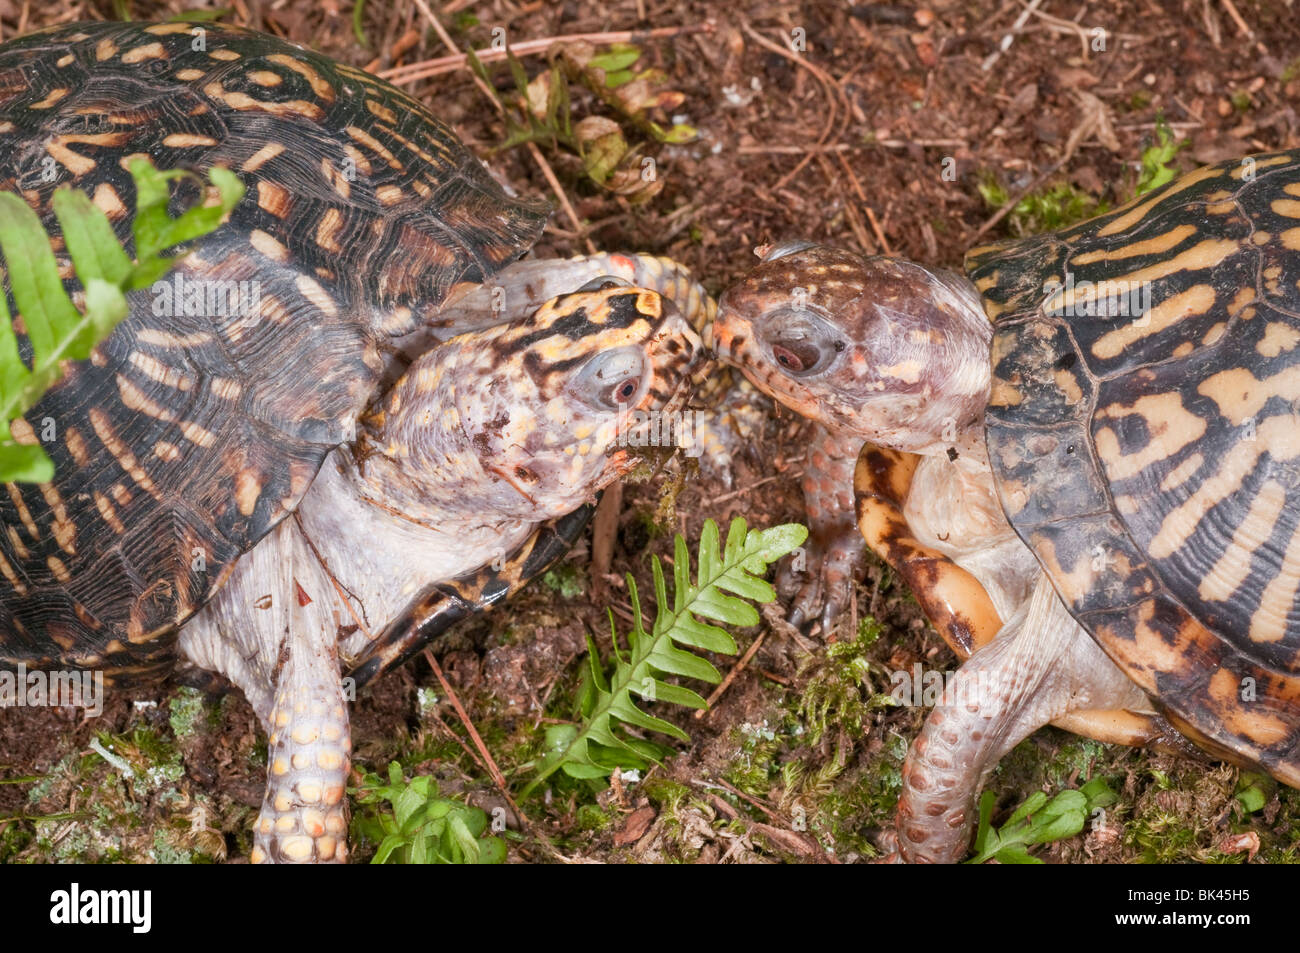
[352,761,506,863]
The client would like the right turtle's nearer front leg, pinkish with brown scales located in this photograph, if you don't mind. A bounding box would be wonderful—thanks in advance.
[897,576,1144,863]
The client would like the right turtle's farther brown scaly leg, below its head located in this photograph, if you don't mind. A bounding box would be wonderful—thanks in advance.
[777,425,866,636]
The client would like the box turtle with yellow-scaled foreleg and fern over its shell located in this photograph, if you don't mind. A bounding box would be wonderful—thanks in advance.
[0,22,710,861]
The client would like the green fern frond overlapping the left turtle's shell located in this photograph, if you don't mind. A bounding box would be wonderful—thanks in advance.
[0,157,244,482]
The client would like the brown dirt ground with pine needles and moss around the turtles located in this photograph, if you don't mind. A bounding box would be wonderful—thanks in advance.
[0,0,1300,863]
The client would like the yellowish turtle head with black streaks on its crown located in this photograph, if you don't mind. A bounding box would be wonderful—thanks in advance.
[376,278,705,520]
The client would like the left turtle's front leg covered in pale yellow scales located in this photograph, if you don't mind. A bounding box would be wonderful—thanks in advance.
[251,580,351,863]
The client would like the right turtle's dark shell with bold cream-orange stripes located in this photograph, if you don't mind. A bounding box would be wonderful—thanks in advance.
[966,151,1300,785]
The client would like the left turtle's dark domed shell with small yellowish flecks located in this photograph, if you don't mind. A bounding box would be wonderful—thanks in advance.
[0,23,546,683]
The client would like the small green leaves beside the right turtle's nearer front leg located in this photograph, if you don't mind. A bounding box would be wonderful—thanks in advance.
[967,777,1115,863]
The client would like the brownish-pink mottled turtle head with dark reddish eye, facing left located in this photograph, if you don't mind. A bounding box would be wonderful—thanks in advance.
[711,242,991,452]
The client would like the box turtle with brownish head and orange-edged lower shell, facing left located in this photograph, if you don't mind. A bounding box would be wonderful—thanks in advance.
[712,151,1300,861]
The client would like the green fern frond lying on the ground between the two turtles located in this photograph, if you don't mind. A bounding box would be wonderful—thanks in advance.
[524,517,807,794]
